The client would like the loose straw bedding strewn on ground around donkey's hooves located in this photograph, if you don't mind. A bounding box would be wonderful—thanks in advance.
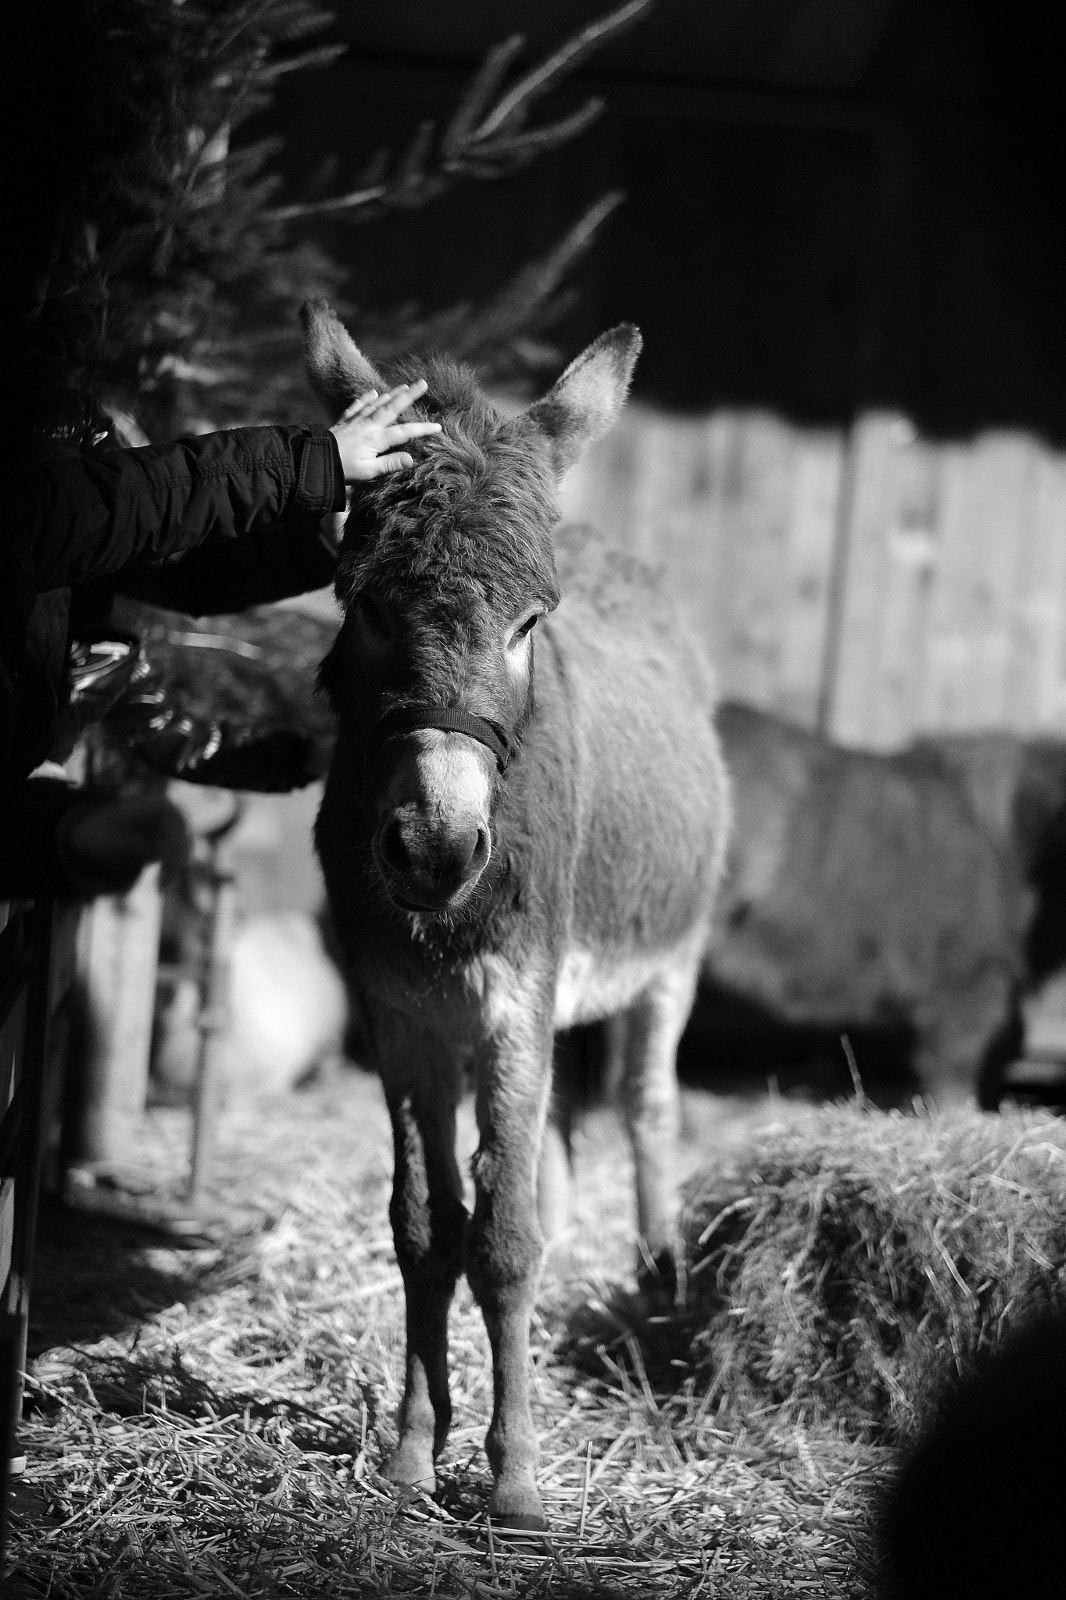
[5,1074,1061,1600]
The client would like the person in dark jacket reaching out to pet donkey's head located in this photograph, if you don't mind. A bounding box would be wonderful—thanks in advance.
[0,381,439,899]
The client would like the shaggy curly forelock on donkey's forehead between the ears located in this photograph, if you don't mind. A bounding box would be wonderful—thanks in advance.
[336,357,559,614]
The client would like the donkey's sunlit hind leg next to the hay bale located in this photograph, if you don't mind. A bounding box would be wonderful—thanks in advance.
[613,960,696,1298]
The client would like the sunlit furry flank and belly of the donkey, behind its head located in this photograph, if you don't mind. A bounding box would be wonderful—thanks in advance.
[530,526,728,1027]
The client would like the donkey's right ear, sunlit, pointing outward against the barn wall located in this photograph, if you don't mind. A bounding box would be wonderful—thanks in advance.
[525,322,642,477]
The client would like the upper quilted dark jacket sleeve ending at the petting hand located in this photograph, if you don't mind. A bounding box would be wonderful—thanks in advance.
[23,426,344,603]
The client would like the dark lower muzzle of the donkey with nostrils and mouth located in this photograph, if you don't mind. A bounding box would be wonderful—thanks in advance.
[375,808,491,912]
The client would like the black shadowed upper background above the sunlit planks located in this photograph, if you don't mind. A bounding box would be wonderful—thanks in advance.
[264,0,1066,440]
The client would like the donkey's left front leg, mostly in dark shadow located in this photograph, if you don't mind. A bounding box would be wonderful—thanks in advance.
[381,1038,466,1494]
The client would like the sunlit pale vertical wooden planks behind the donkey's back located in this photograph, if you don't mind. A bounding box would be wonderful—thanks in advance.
[563,403,1066,749]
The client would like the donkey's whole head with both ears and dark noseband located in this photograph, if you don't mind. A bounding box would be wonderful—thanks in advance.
[303,301,640,915]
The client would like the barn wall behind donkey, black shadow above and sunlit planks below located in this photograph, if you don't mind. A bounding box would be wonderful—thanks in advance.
[252,10,1066,747]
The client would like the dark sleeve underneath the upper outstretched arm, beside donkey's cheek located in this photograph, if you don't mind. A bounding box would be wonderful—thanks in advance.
[114,517,336,616]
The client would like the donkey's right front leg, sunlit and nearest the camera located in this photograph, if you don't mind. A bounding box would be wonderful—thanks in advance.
[466,1018,551,1530]
